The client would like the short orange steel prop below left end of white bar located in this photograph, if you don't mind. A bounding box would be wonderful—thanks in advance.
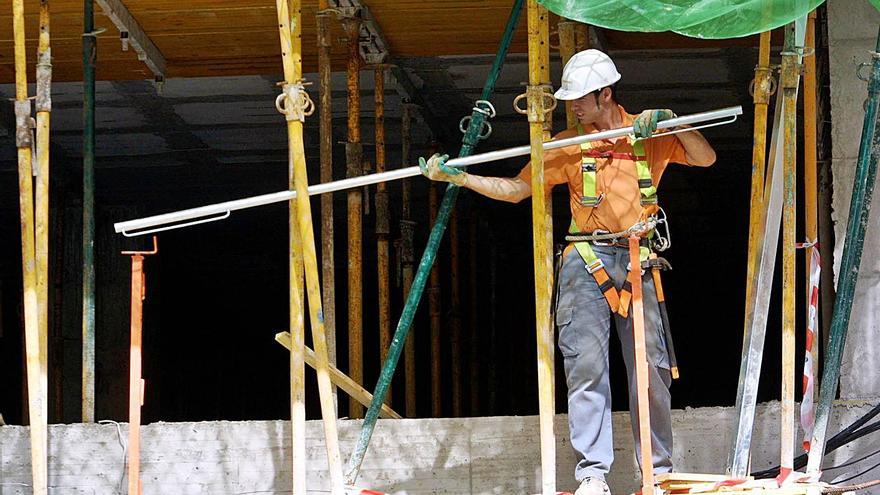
[122,236,159,495]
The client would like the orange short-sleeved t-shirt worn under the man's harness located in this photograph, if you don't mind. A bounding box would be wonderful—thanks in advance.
[517,105,690,232]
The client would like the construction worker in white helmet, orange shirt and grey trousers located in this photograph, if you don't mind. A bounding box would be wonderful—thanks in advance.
[420,50,715,495]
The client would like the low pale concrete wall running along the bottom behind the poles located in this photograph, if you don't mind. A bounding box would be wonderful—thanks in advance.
[0,401,880,495]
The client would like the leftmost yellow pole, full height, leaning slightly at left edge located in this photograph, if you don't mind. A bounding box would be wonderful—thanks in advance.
[12,0,48,495]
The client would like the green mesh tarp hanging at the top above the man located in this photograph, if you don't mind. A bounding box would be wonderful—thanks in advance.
[538,0,828,39]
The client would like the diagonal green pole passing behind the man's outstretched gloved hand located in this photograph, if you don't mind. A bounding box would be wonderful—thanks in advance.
[346,0,523,483]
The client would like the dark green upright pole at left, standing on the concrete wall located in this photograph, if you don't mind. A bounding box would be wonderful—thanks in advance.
[82,0,98,423]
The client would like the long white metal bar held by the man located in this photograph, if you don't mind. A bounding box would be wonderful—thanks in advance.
[113,106,742,236]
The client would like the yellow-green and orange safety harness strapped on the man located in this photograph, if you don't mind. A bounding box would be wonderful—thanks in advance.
[566,124,657,318]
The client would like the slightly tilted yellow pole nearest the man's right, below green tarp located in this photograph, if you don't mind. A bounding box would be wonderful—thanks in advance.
[746,31,774,317]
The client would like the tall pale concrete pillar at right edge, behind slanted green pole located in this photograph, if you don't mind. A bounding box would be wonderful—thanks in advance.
[823,0,880,398]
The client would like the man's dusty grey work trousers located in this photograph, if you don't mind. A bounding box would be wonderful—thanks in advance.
[556,246,672,481]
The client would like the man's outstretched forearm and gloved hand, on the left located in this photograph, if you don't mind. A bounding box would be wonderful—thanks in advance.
[419,155,532,203]
